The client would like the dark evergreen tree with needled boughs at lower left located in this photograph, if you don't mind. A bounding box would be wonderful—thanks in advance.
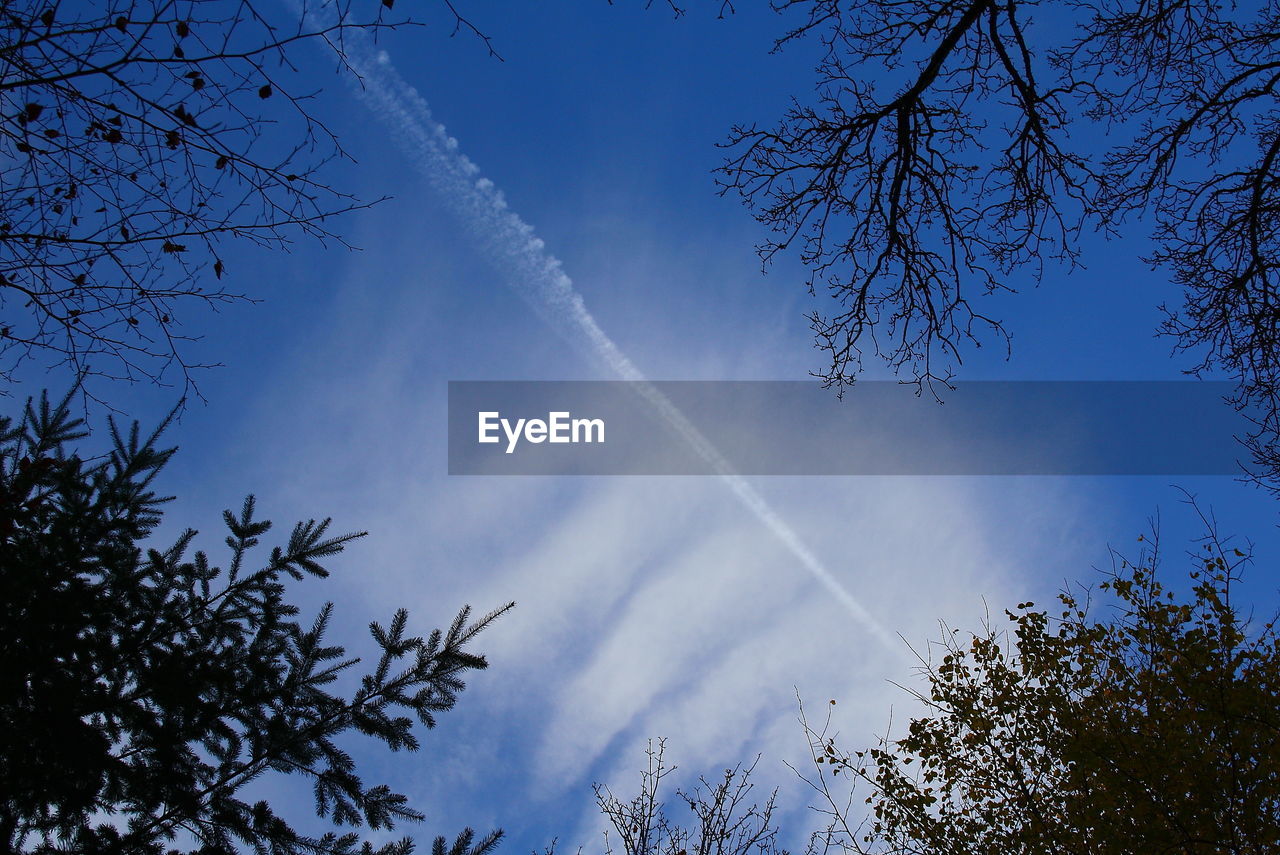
[0,398,511,855]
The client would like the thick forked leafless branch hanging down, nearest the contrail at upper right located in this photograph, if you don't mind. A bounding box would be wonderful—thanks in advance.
[721,0,1093,384]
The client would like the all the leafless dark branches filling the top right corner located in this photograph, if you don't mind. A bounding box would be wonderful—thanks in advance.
[719,0,1280,468]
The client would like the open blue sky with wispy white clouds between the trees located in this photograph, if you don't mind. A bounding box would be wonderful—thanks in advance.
[24,0,1280,852]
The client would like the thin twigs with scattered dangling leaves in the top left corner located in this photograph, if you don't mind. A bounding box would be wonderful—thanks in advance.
[0,0,492,387]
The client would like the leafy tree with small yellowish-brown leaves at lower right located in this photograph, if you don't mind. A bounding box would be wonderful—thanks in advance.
[805,506,1280,855]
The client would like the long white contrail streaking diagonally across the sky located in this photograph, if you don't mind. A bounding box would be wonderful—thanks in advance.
[325,32,900,653]
